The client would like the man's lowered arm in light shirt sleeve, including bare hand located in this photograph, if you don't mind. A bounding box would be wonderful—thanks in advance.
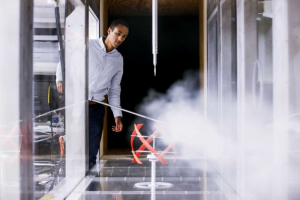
[108,70,123,132]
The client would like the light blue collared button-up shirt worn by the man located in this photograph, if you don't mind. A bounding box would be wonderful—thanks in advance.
[56,37,123,117]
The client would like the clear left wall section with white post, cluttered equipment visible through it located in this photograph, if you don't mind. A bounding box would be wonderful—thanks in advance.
[33,0,88,199]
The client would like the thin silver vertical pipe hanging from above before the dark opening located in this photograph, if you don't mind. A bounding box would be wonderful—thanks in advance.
[152,0,158,76]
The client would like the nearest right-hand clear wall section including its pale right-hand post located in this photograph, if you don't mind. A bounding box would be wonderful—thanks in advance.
[237,0,300,200]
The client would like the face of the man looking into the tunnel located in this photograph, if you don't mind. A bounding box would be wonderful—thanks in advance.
[106,24,129,48]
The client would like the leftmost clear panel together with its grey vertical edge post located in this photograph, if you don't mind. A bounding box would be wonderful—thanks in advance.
[0,0,33,200]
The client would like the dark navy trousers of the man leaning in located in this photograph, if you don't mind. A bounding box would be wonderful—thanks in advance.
[89,104,105,169]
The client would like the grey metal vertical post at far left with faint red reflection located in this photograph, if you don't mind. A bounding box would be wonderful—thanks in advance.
[19,0,34,199]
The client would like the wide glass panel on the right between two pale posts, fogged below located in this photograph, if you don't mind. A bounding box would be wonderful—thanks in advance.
[237,0,276,199]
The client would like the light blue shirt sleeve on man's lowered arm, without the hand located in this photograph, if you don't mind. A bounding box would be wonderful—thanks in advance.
[108,66,123,117]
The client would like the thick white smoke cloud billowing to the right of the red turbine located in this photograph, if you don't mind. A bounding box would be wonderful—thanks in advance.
[132,72,299,200]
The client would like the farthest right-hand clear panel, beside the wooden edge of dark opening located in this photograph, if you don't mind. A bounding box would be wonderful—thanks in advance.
[207,0,237,195]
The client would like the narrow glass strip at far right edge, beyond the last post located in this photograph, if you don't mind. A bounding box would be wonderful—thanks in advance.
[288,0,300,199]
